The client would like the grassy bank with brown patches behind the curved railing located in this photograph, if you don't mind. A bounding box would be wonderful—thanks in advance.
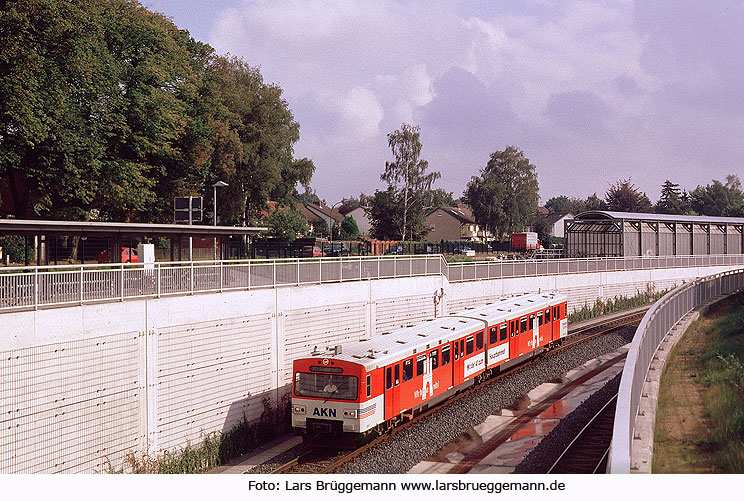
[653,293,744,473]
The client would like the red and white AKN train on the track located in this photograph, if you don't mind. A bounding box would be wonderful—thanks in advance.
[292,294,567,445]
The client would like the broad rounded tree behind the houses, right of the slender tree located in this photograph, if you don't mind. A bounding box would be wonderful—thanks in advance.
[463,146,539,239]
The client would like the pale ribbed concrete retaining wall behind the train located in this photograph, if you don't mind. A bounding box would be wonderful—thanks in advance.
[0,268,724,473]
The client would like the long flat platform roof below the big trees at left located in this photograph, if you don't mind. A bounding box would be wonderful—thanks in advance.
[0,219,268,237]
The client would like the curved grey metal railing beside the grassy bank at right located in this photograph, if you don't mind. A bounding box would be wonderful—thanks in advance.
[608,269,744,473]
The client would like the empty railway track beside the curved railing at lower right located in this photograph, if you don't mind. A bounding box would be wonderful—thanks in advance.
[547,393,617,474]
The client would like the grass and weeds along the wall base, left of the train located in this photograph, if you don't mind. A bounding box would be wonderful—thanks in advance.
[105,398,289,474]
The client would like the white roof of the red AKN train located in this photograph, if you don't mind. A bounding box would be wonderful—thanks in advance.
[310,293,566,371]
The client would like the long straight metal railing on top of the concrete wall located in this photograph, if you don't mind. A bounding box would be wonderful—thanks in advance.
[0,254,744,311]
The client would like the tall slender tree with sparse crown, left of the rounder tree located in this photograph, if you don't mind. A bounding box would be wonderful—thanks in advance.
[380,123,440,240]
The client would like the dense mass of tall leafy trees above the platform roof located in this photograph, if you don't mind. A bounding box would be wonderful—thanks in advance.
[0,0,315,224]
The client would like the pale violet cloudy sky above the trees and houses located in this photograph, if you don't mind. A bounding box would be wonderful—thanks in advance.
[141,0,744,205]
